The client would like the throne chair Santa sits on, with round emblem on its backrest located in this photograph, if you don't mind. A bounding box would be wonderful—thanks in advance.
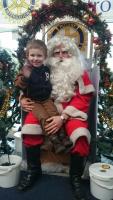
[20,20,99,177]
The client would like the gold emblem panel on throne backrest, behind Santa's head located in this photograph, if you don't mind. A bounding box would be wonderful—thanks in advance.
[47,21,88,54]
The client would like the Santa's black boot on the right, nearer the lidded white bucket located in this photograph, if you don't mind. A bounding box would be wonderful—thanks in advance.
[70,154,85,200]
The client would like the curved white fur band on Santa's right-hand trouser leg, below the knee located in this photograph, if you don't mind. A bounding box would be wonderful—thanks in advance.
[70,127,91,144]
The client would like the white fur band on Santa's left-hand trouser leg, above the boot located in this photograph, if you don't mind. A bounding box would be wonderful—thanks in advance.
[21,124,42,135]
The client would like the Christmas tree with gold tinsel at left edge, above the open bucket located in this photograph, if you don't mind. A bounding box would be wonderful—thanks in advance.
[0,48,20,138]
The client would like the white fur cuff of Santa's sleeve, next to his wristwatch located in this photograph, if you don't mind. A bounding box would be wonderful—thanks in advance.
[62,106,88,121]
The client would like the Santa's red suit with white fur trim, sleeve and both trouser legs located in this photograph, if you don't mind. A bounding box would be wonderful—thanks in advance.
[23,71,94,156]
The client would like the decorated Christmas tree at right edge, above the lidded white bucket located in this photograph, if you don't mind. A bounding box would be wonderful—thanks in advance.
[98,68,113,155]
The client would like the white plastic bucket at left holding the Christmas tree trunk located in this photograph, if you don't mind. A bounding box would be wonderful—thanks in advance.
[0,155,22,188]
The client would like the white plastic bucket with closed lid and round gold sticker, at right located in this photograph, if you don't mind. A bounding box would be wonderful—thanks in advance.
[89,163,113,200]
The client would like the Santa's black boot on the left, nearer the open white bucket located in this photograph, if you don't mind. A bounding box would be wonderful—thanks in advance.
[18,145,42,191]
